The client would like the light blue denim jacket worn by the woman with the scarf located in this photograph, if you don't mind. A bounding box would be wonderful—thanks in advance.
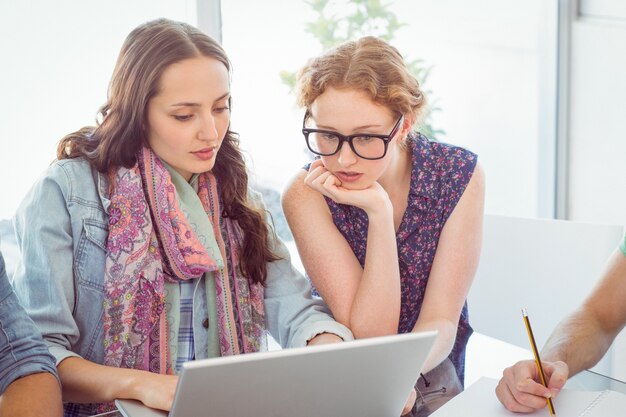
[14,158,352,415]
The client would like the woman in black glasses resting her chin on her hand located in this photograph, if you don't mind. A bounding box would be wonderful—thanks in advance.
[283,37,484,415]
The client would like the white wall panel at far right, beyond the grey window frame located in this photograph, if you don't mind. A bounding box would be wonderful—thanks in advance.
[568,11,626,228]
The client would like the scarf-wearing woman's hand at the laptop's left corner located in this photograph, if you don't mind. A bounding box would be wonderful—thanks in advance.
[132,371,178,411]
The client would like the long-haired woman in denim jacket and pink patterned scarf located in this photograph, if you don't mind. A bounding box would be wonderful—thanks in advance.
[14,19,351,416]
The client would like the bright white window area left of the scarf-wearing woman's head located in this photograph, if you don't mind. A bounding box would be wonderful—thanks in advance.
[0,0,196,219]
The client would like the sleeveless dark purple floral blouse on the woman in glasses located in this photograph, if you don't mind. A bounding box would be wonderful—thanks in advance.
[326,133,477,382]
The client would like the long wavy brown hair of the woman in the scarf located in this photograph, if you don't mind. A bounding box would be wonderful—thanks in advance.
[57,19,279,284]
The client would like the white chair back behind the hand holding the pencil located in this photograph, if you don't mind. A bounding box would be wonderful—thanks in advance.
[468,215,624,374]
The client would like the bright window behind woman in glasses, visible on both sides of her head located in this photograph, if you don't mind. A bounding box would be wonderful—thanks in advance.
[222,0,557,237]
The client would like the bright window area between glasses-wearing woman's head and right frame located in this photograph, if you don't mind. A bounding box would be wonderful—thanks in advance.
[398,0,556,217]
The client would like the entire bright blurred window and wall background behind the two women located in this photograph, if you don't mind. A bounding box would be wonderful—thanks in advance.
[0,0,626,276]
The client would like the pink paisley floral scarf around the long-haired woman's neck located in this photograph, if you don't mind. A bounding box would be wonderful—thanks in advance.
[104,147,265,374]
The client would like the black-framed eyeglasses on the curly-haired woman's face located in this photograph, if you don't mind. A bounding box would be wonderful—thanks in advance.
[302,112,404,160]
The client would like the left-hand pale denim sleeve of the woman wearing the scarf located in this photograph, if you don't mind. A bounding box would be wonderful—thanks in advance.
[12,165,80,364]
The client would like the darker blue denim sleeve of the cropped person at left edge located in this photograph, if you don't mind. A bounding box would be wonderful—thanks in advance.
[0,254,58,394]
